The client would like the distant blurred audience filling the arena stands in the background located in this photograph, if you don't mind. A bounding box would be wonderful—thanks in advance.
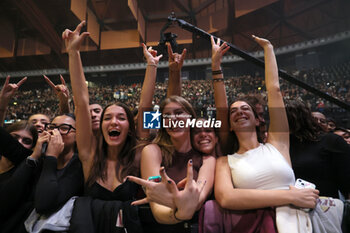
[2,62,350,124]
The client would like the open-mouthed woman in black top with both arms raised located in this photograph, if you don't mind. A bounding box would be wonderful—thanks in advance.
[62,22,162,232]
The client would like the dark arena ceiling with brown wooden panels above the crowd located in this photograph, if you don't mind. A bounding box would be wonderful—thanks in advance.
[0,0,350,72]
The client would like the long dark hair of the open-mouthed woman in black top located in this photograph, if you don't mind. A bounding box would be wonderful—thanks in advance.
[87,102,139,185]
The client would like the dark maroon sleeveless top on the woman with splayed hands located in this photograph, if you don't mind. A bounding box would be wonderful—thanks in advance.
[165,149,203,183]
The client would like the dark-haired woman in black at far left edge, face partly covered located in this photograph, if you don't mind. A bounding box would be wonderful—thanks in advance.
[0,121,42,233]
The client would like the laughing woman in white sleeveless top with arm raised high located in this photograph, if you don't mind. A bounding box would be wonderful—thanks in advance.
[212,36,318,232]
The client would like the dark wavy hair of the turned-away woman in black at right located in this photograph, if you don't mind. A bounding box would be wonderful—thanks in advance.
[285,100,323,141]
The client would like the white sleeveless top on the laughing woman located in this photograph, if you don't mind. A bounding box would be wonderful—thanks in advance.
[227,143,295,190]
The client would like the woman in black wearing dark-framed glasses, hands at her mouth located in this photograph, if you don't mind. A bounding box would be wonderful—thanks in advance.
[35,114,84,215]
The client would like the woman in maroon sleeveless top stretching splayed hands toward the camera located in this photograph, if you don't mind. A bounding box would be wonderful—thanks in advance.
[127,96,215,232]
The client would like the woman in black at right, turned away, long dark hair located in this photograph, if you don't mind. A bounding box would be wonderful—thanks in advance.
[286,101,350,198]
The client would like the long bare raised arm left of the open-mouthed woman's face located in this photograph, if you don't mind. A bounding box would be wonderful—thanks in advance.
[62,21,94,180]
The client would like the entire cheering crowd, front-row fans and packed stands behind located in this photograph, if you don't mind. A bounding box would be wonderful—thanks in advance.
[0,22,350,233]
